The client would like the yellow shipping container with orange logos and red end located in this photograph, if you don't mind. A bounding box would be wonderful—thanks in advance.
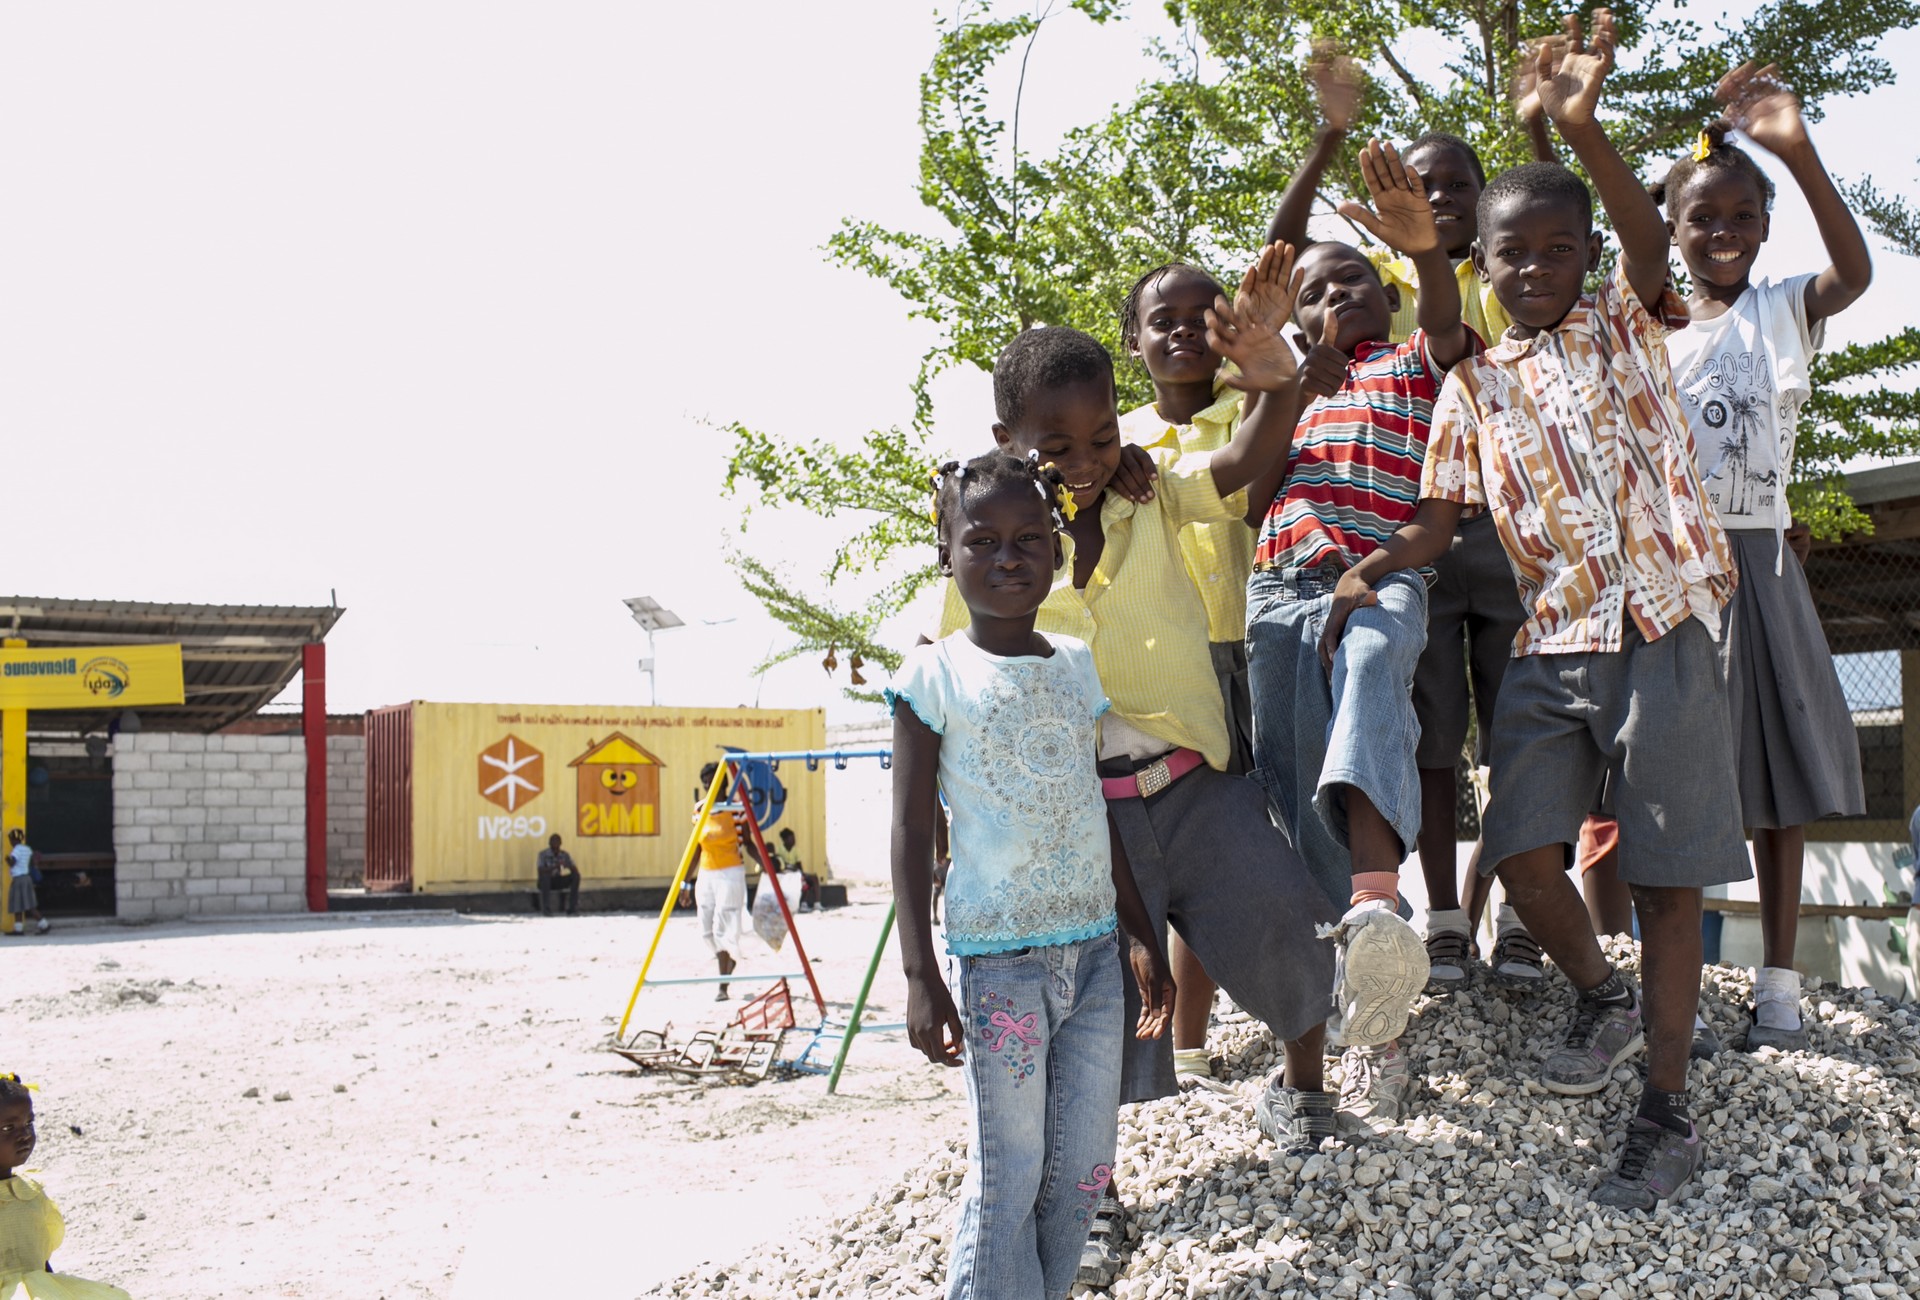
[369,703,826,893]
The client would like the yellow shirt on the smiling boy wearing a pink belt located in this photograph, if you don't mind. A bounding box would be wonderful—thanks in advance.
[941,447,1246,772]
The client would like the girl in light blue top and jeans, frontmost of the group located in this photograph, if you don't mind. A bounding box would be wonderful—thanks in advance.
[887,451,1173,1300]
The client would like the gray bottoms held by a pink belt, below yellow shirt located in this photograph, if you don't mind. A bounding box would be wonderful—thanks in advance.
[1106,766,1340,1102]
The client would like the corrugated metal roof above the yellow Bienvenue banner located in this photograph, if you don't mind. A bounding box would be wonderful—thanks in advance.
[0,595,346,732]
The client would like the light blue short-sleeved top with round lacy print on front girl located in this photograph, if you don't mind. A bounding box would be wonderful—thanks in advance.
[887,632,1116,956]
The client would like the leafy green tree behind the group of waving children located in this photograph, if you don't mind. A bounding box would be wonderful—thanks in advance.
[726,0,1920,691]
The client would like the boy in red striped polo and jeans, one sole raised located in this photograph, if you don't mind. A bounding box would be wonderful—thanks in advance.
[1246,140,1476,1133]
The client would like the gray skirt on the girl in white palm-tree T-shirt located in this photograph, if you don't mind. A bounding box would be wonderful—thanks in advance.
[1720,528,1866,830]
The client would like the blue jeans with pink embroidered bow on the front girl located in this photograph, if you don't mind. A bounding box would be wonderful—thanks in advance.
[947,931,1125,1300]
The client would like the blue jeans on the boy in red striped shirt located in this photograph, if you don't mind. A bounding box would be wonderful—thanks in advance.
[1246,566,1427,908]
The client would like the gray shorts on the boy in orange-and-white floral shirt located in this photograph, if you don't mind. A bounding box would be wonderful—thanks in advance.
[1480,618,1753,887]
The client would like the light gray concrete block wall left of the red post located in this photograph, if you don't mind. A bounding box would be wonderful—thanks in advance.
[113,732,307,920]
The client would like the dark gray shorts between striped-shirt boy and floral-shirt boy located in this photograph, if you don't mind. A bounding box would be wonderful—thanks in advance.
[1413,511,1526,770]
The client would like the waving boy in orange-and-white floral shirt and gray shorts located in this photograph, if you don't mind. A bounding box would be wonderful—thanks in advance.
[1327,10,1749,1208]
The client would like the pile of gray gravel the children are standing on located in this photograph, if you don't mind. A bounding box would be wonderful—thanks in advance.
[660,943,1920,1300]
